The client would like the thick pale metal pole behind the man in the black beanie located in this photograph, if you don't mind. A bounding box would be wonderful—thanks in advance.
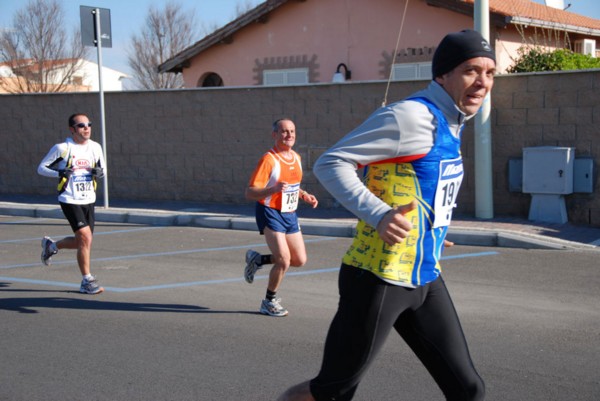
[474,0,494,219]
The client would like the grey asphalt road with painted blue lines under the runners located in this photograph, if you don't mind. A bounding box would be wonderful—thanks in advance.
[0,216,600,401]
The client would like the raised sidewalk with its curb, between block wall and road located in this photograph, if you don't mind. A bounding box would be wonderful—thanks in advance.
[0,195,600,251]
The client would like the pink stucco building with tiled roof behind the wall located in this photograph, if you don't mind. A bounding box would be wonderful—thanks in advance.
[159,0,600,88]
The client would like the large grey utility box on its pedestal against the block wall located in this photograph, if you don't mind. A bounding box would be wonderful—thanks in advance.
[523,146,575,223]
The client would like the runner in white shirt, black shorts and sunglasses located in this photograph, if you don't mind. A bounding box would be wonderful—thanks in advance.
[38,114,105,294]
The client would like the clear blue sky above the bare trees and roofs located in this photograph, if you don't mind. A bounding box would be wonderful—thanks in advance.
[0,0,600,83]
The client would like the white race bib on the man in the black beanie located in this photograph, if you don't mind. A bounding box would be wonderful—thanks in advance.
[433,157,463,228]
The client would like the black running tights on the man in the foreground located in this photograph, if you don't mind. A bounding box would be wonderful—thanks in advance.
[310,265,485,401]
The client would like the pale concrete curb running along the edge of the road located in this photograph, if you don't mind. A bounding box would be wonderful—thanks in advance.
[0,202,600,251]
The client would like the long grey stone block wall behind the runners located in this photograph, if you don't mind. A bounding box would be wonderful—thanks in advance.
[0,70,600,226]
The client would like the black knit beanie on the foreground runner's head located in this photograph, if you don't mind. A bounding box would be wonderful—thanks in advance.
[431,29,496,78]
